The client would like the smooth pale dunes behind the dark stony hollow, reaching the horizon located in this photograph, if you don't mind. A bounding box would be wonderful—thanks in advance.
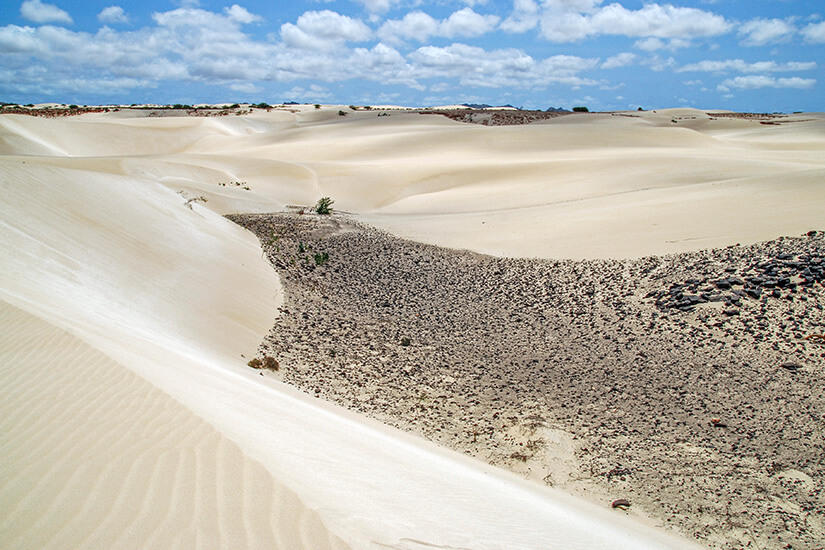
[2,107,825,258]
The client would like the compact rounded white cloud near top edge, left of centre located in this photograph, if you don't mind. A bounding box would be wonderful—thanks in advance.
[281,10,372,50]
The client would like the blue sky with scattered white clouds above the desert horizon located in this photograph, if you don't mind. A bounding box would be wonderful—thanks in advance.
[0,0,825,112]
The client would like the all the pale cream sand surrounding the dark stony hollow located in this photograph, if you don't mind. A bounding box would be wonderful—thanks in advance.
[0,106,825,548]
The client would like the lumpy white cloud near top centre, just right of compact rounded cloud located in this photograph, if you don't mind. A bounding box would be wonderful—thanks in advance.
[378,8,499,45]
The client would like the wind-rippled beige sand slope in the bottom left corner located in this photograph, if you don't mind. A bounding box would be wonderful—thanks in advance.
[0,303,347,549]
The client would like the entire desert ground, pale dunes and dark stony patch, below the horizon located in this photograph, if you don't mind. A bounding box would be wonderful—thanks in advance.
[0,105,825,550]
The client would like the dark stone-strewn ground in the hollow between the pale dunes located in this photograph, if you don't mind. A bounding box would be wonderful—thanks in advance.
[231,213,825,548]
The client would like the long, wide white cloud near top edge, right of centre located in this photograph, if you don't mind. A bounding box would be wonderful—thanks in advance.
[541,4,732,42]
